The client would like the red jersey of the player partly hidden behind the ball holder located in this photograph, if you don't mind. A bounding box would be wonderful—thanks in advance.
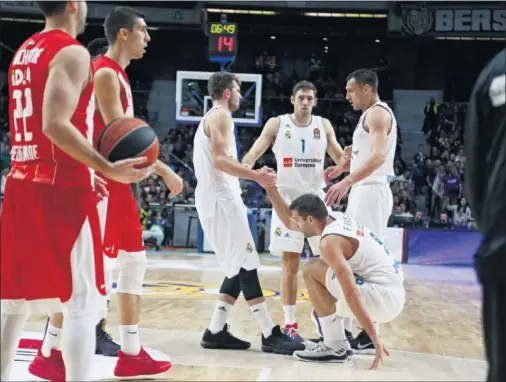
[92,56,134,147]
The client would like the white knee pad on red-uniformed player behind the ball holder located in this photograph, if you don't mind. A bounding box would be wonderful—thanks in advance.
[116,251,148,296]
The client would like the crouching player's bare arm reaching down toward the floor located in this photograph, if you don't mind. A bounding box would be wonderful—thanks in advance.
[320,235,377,339]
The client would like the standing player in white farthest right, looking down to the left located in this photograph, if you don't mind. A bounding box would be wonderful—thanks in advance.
[325,69,397,354]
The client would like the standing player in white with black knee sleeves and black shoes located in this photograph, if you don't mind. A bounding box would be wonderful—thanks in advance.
[193,72,305,354]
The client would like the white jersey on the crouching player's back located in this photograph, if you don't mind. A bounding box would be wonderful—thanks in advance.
[322,212,404,284]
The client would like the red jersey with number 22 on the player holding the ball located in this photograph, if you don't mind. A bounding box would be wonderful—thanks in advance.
[9,30,95,187]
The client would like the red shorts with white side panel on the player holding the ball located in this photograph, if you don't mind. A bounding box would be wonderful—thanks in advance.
[0,178,105,314]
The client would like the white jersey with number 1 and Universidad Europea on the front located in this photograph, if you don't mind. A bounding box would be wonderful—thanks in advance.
[272,114,327,194]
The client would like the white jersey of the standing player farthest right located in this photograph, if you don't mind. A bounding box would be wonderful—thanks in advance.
[350,102,397,184]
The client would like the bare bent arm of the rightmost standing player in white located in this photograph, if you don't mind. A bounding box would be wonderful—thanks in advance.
[345,107,392,186]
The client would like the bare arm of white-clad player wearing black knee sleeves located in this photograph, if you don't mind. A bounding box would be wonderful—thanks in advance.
[208,109,276,186]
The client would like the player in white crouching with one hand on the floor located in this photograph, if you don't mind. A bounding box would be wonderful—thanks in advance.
[267,188,406,369]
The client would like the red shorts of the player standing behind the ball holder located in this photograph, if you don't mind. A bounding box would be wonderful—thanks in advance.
[99,181,144,258]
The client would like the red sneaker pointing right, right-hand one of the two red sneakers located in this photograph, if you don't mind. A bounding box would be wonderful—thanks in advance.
[114,348,172,378]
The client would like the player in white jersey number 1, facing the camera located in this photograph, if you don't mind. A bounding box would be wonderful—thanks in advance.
[242,81,349,342]
